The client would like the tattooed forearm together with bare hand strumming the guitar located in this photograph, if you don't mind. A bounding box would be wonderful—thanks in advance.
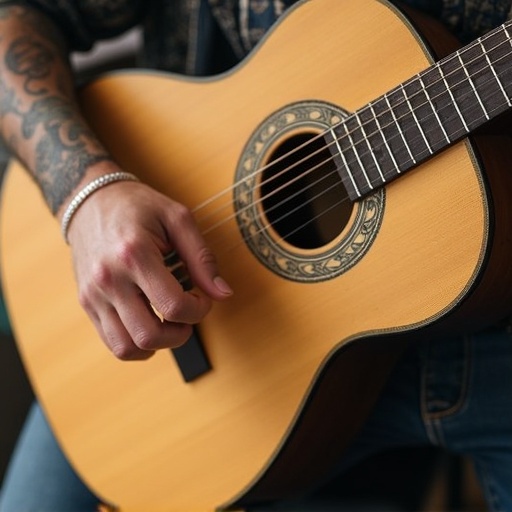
[0,7,232,359]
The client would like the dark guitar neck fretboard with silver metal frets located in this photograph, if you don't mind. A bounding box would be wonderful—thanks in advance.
[326,22,512,201]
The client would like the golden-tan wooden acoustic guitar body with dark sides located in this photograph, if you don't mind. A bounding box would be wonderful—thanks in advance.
[1,0,512,512]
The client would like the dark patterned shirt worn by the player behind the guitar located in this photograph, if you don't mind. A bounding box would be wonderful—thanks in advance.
[0,0,512,74]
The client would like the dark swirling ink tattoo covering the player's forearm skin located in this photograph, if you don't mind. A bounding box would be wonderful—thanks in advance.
[0,9,110,214]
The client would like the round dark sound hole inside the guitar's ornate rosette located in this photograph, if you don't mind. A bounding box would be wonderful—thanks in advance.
[261,133,353,249]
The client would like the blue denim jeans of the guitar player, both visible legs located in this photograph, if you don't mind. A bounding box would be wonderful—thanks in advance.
[0,327,512,512]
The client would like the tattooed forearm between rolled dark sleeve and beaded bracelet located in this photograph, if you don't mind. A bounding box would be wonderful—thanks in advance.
[0,7,113,215]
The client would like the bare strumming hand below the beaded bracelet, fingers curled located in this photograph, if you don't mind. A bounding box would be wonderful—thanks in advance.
[68,178,232,360]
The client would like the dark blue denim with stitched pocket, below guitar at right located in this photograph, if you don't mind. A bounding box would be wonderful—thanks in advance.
[341,326,512,512]
